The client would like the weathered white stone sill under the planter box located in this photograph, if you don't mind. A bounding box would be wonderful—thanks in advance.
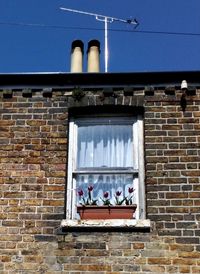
[61,219,151,231]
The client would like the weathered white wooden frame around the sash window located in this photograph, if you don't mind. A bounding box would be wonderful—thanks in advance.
[66,114,146,220]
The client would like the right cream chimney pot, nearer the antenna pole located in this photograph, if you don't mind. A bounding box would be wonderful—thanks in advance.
[87,40,100,72]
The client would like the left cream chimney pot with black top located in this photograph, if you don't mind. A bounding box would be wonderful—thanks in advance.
[70,40,84,73]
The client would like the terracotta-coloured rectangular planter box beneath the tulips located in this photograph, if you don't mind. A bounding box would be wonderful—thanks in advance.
[77,204,137,220]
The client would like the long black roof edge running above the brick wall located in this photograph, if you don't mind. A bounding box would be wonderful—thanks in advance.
[0,71,200,89]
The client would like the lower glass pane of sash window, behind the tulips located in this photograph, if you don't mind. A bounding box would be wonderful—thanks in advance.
[76,174,137,205]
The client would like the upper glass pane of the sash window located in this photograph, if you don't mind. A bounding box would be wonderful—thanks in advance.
[77,124,133,168]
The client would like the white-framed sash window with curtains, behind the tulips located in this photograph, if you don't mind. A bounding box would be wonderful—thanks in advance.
[67,115,145,219]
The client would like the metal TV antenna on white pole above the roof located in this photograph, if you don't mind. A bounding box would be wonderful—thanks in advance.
[60,7,139,72]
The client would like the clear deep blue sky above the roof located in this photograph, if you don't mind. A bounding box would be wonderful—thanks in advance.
[0,0,200,73]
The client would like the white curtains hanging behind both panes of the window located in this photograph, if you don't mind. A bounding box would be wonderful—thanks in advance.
[76,124,133,204]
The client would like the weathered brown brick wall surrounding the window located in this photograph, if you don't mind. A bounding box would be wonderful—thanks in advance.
[0,89,200,274]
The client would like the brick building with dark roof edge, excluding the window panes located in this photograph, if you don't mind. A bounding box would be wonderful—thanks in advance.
[0,52,200,274]
